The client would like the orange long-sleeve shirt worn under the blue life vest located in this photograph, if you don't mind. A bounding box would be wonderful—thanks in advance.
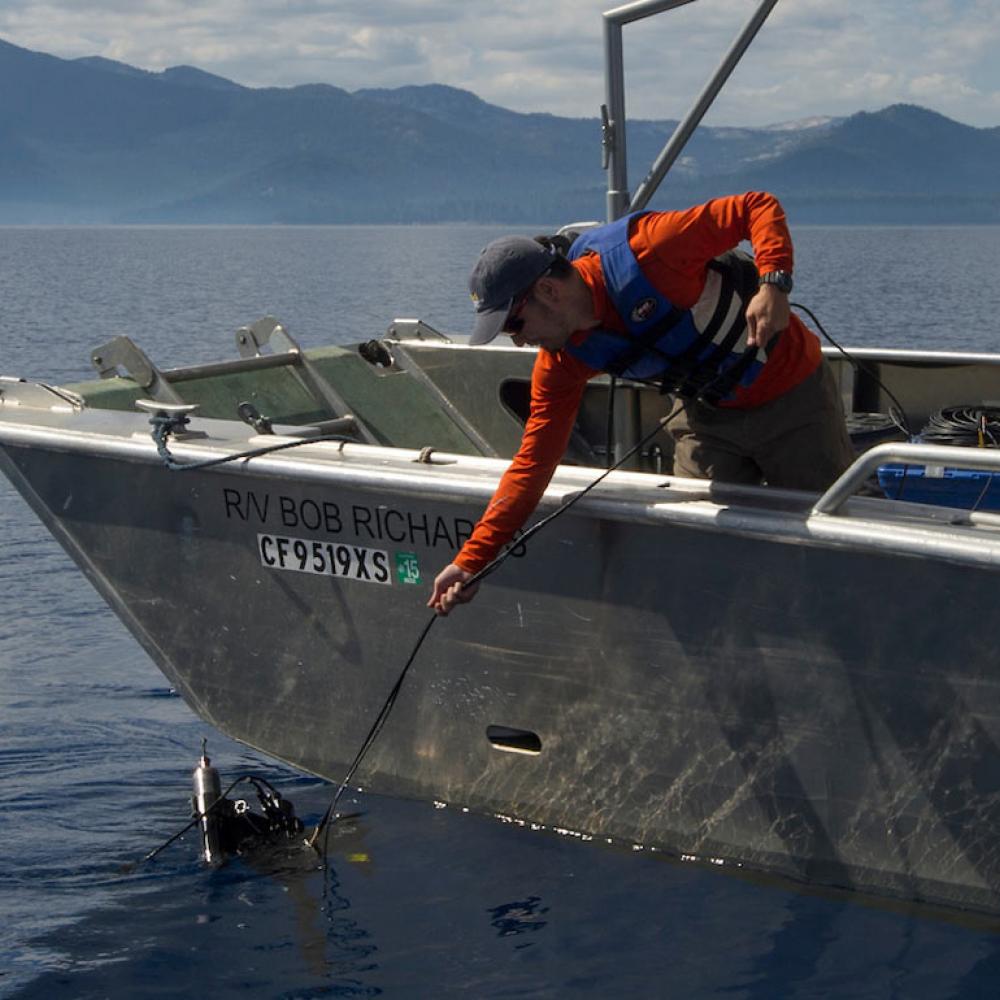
[455,191,822,573]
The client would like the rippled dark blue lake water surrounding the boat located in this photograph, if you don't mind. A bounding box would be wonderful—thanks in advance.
[0,226,1000,1000]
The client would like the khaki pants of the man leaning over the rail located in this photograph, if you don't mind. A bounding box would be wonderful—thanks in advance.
[668,360,854,491]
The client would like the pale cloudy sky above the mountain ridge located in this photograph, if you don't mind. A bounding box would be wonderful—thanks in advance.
[0,0,1000,127]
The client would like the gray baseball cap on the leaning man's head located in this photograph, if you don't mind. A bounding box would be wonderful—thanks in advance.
[469,236,553,344]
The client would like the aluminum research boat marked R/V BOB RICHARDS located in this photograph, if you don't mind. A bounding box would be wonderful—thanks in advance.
[0,2,1000,912]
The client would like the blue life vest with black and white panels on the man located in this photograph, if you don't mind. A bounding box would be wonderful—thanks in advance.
[564,213,773,402]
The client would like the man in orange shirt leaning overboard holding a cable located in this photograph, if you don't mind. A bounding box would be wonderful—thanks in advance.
[428,192,853,615]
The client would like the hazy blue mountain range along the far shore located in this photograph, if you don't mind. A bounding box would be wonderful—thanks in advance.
[0,41,1000,225]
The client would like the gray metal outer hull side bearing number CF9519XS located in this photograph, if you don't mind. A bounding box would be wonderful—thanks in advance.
[0,422,1000,911]
